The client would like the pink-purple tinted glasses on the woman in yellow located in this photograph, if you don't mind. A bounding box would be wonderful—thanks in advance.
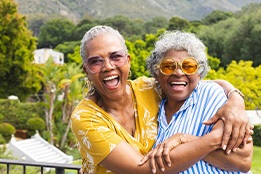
[86,51,127,73]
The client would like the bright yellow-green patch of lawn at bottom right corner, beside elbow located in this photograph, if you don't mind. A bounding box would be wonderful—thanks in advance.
[251,146,261,174]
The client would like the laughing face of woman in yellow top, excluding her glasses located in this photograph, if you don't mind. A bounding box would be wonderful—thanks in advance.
[83,34,130,100]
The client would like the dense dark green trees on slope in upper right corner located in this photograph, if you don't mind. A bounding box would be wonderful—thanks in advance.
[198,4,261,68]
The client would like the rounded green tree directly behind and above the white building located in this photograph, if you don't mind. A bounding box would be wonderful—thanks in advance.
[38,18,75,48]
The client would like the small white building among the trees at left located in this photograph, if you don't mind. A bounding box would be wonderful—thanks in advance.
[33,48,64,65]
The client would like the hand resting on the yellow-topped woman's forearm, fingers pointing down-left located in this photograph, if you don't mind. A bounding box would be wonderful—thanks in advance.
[139,133,193,173]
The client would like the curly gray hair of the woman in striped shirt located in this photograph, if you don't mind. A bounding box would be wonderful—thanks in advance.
[146,31,209,79]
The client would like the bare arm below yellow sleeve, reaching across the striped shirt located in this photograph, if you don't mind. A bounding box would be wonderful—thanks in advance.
[100,127,222,174]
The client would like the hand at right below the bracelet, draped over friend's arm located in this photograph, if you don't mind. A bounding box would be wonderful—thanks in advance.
[204,92,249,154]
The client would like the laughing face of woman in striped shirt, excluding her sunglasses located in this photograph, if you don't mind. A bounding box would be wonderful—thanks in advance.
[156,50,200,104]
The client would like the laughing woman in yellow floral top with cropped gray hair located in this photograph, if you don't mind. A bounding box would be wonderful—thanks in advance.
[71,26,250,174]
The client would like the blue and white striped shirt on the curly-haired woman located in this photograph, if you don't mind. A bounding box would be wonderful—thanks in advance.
[154,81,251,174]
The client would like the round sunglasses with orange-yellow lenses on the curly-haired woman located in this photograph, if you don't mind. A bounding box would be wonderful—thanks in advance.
[159,58,199,75]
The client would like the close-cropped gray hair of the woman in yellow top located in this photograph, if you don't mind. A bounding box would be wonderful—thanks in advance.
[80,25,128,61]
